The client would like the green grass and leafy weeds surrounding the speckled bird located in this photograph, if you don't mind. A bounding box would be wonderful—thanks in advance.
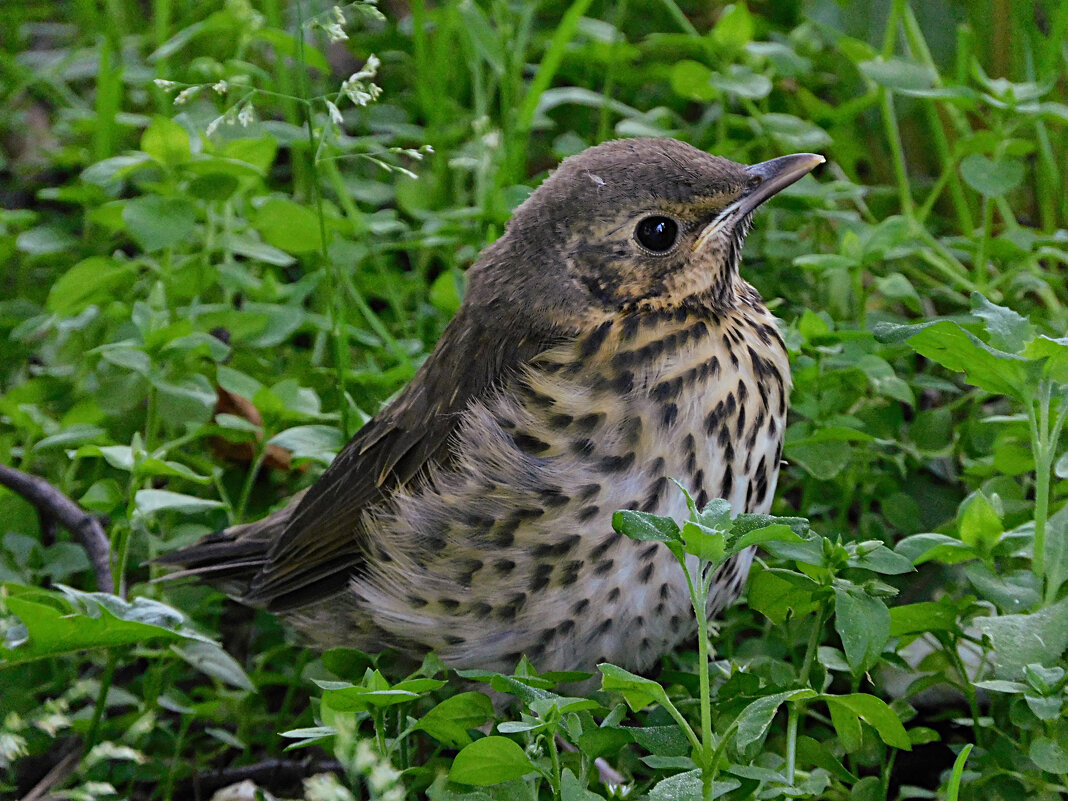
[0,0,1068,801]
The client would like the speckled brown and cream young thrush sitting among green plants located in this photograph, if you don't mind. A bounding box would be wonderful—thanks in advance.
[159,138,823,672]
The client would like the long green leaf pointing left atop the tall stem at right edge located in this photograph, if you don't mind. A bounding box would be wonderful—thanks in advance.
[873,320,1037,403]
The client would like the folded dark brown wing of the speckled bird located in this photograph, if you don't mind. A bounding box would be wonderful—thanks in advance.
[242,297,568,611]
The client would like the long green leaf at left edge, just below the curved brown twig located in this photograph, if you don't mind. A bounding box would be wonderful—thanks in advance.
[0,584,210,668]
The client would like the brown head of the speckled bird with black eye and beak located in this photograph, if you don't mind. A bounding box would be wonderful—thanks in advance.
[489,139,823,322]
